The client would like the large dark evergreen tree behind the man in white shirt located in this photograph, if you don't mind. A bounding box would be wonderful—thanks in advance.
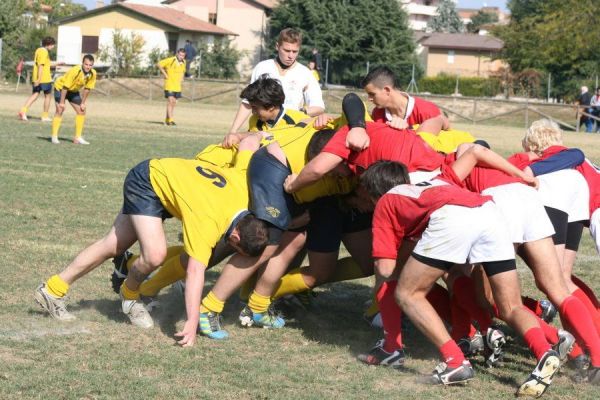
[269,0,421,85]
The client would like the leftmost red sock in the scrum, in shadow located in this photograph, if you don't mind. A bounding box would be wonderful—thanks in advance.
[376,281,403,353]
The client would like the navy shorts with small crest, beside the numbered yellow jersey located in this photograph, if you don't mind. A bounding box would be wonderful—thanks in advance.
[248,147,303,231]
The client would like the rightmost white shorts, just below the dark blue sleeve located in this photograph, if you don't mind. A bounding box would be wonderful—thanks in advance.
[537,169,590,222]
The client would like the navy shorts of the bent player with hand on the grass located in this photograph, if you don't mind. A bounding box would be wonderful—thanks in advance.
[121,160,172,220]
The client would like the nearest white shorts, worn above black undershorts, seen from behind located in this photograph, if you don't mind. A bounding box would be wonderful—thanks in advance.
[414,201,515,264]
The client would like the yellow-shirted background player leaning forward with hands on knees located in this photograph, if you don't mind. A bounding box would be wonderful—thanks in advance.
[51,54,96,144]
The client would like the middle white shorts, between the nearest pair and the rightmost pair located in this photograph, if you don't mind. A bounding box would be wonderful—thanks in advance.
[481,183,554,243]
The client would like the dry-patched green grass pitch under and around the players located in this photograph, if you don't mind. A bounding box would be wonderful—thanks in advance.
[0,92,600,400]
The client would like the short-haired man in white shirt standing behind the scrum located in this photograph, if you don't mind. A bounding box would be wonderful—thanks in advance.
[226,28,325,139]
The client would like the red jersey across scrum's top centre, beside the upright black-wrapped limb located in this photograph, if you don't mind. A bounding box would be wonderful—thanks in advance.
[323,122,444,174]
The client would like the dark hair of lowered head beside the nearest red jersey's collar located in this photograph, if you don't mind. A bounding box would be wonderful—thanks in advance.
[360,160,410,200]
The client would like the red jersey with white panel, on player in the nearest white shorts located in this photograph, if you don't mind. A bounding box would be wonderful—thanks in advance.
[373,175,492,259]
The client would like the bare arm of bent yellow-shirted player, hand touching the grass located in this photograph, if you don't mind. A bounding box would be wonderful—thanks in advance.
[175,256,206,347]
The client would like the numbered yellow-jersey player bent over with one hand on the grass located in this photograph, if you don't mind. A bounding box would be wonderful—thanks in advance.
[35,135,267,346]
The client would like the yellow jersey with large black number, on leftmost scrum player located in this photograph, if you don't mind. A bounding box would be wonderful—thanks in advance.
[150,151,252,266]
